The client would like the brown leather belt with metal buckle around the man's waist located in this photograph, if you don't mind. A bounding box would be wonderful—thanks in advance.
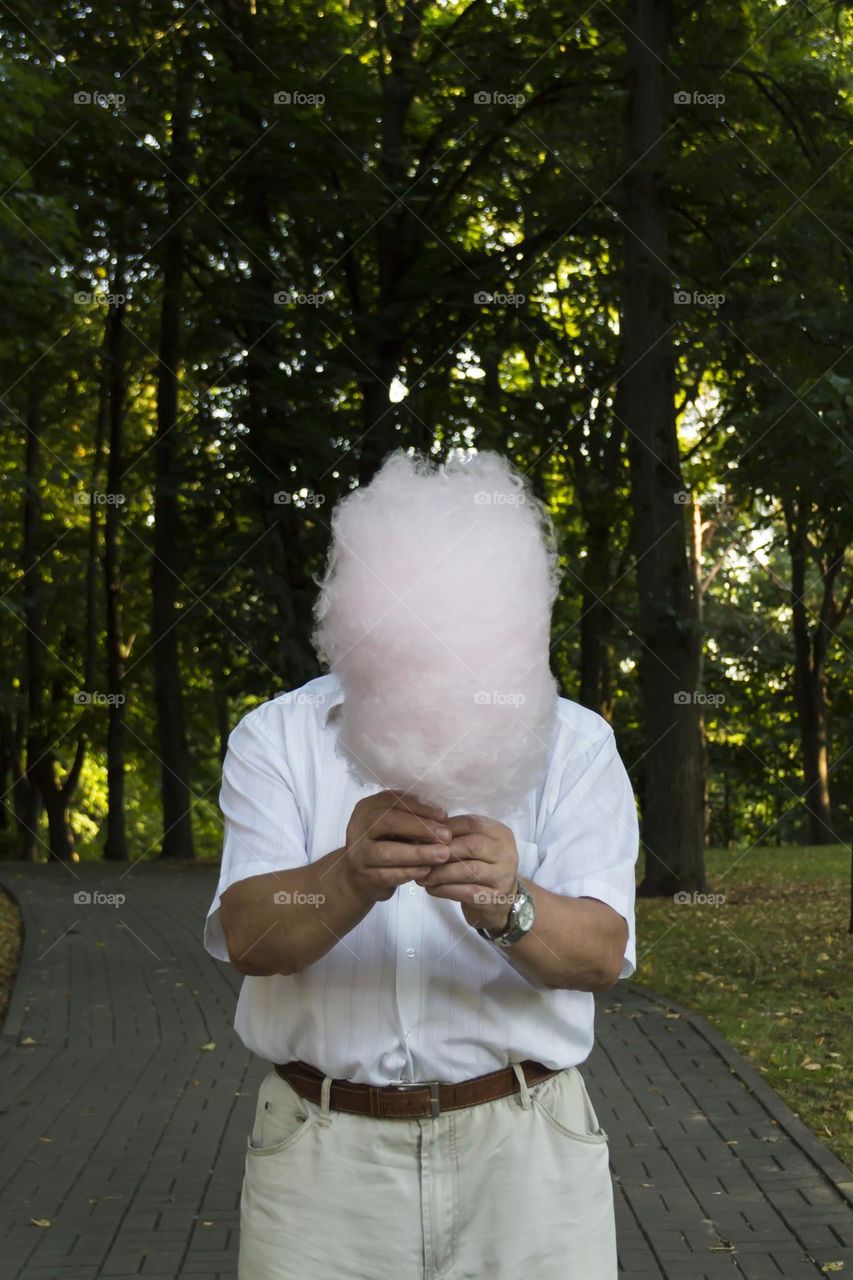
[268,1059,558,1120]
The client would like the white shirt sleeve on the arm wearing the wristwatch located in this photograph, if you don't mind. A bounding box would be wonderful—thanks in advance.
[534,731,639,978]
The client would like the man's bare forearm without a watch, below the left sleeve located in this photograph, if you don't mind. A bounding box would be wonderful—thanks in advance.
[220,849,373,977]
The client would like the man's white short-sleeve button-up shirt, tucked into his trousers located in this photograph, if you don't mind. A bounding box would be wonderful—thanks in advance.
[204,673,639,1084]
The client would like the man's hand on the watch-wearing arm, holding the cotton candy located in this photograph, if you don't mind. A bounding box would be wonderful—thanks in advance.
[420,813,519,933]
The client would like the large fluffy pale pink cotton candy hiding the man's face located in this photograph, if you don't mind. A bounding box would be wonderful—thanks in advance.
[308,449,560,817]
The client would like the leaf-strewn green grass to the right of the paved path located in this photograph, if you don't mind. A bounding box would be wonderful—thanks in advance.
[635,846,853,1166]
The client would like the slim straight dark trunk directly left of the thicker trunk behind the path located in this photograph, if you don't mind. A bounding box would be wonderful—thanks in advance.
[103,280,127,863]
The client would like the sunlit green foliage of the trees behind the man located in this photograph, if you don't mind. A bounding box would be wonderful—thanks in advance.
[0,0,853,858]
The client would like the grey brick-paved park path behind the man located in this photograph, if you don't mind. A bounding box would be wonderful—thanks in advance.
[0,863,853,1280]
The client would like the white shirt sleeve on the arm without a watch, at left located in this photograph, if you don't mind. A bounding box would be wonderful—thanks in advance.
[204,712,309,960]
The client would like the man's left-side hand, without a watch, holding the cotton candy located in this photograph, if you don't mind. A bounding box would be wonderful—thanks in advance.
[346,791,452,902]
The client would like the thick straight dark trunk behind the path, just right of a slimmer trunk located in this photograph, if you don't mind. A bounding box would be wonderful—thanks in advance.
[151,76,193,859]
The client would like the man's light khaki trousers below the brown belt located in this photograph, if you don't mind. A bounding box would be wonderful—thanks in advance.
[238,1066,616,1280]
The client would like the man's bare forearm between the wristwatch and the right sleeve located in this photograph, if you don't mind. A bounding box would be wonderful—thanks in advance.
[496,879,628,991]
